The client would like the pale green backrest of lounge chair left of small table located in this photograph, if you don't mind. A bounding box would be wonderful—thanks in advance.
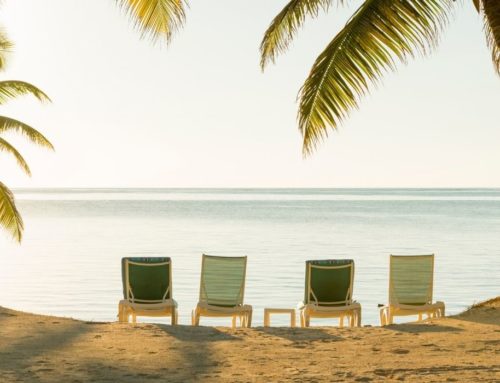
[200,254,247,307]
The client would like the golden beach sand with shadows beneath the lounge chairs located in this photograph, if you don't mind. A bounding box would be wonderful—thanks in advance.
[0,297,500,383]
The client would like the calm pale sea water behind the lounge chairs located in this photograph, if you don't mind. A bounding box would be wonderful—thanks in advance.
[0,189,500,325]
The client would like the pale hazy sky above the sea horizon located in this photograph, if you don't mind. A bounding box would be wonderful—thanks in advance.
[0,0,500,188]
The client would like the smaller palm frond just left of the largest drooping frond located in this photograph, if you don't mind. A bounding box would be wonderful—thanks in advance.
[260,0,347,70]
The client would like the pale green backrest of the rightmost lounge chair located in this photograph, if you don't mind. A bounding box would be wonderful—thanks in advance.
[389,254,434,305]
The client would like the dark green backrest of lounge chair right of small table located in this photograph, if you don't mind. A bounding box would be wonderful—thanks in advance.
[304,259,354,306]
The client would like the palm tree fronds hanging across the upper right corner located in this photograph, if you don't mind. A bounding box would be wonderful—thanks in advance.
[260,0,500,155]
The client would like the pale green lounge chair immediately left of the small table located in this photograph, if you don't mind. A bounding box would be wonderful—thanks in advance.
[191,254,252,328]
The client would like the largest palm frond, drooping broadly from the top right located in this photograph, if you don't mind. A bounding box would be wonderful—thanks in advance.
[298,0,454,155]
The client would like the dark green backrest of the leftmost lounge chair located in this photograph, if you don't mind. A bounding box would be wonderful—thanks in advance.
[122,257,172,303]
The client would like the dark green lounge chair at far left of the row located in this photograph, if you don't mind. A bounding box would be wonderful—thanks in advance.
[118,257,178,324]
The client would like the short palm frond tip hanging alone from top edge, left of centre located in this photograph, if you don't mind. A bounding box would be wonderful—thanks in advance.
[116,0,186,42]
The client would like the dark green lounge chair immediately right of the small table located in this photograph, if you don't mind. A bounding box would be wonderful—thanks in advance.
[298,259,361,327]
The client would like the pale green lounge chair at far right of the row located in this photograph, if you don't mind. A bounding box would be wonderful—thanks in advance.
[380,254,445,326]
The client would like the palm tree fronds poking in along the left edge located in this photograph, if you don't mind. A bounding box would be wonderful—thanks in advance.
[0,31,53,242]
